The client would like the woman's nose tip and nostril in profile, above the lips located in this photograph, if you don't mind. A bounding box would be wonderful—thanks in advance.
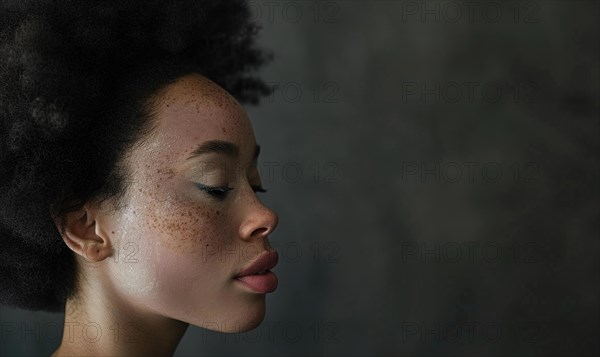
[240,199,279,240]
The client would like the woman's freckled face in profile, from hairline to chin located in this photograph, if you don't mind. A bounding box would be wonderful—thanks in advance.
[98,75,277,332]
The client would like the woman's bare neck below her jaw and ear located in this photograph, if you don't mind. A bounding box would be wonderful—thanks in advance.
[52,272,188,356]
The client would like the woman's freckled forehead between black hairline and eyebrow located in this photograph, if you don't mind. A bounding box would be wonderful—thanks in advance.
[139,74,255,163]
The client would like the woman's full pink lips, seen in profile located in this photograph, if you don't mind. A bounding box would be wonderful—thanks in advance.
[234,251,279,294]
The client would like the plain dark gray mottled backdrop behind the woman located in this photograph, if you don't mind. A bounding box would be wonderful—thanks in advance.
[0,1,600,356]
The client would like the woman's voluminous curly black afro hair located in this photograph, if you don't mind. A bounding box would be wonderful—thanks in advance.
[0,0,271,311]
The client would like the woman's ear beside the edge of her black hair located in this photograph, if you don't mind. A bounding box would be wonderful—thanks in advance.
[56,204,113,262]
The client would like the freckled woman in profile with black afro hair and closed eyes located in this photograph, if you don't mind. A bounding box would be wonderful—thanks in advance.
[0,1,277,356]
